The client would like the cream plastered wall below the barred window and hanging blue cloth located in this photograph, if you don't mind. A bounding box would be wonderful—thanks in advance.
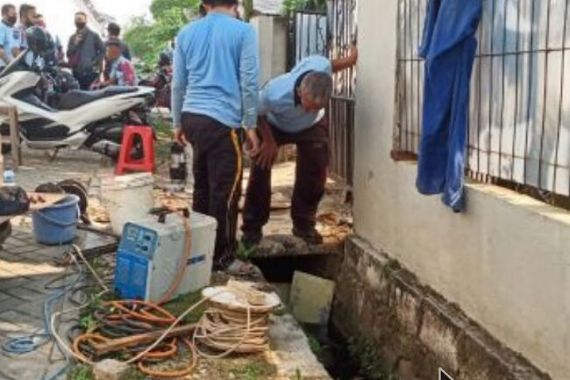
[354,0,570,379]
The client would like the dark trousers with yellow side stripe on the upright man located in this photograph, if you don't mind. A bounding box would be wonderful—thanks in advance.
[182,113,243,262]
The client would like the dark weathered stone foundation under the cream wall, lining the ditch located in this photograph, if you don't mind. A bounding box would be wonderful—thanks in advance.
[332,237,550,380]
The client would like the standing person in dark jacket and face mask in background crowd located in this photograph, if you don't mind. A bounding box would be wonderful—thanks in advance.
[67,12,105,90]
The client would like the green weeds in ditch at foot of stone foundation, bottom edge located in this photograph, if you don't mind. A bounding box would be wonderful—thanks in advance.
[348,338,397,380]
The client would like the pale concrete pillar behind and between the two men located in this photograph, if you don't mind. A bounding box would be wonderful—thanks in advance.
[251,16,287,85]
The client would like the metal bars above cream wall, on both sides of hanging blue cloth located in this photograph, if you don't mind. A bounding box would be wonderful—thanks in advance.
[394,0,570,209]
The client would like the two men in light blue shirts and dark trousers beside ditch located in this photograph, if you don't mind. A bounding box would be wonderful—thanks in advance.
[172,0,358,272]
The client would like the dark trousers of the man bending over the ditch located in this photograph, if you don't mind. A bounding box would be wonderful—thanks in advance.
[242,120,329,234]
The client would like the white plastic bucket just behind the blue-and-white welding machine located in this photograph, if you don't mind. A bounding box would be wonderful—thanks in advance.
[101,173,154,235]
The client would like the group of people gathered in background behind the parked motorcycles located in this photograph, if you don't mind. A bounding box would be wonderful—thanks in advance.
[0,4,137,90]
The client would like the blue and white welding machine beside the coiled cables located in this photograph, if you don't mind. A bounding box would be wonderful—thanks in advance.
[115,212,217,301]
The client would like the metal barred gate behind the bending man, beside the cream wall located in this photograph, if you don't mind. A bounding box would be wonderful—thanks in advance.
[288,0,357,185]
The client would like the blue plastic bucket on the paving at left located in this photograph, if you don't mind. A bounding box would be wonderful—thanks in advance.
[32,195,80,245]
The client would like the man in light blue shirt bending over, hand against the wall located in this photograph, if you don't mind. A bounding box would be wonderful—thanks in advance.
[242,48,358,246]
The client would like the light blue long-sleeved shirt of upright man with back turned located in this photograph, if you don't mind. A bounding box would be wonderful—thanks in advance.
[172,12,259,128]
